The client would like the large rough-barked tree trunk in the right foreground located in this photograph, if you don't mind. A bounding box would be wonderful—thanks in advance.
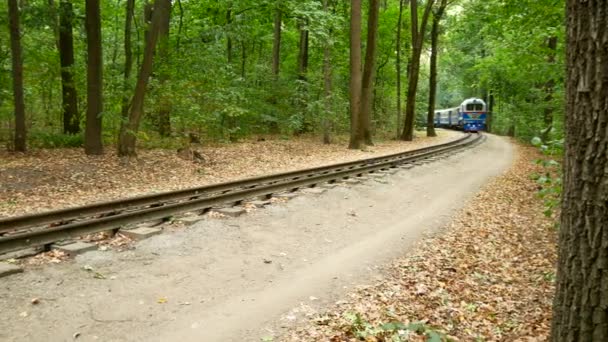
[551,0,608,342]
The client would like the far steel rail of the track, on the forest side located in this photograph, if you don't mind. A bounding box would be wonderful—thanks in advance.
[0,135,468,235]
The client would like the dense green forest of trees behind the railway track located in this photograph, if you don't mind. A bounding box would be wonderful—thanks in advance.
[0,0,565,155]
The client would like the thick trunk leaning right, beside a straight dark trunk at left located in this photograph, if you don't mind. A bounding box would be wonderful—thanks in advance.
[118,0,171,156]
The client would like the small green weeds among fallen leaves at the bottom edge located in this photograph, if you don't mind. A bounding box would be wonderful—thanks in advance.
[344,313,447,342]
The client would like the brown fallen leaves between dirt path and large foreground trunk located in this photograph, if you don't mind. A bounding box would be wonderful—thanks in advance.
[279,145,557,342]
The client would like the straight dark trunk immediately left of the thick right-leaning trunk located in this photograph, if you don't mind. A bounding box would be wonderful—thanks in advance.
[84,0,103,155]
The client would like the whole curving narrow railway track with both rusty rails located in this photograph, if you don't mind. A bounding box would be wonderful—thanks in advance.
[0,134,484,255]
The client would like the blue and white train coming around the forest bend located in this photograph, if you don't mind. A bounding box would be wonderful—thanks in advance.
[435,97,488,132]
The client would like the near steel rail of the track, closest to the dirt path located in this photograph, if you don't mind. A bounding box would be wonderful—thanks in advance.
[0,135,482,254]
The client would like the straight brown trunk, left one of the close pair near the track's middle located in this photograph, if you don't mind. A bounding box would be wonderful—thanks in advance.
[348,0,363,149]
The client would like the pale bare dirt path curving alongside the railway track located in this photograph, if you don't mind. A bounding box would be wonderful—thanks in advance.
[0,136,512,341]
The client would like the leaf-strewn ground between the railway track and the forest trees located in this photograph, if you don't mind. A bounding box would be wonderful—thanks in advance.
[0,130,462,218]
